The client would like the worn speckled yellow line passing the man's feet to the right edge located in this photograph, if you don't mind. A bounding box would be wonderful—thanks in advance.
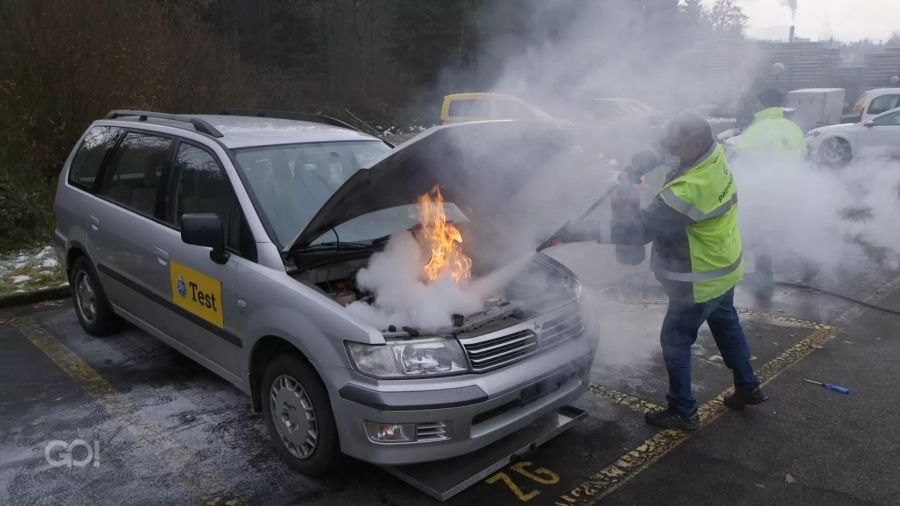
[555,277,900,506]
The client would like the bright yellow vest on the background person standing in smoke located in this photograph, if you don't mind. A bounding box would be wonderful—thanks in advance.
[737,107,808,162]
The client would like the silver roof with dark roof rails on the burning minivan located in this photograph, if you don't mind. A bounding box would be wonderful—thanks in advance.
[104,114,380,149]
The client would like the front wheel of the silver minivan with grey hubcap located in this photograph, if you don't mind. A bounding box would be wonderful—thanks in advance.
[260,354,343,477]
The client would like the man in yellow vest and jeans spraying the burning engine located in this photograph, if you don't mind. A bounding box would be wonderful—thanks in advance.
[557,113,767,430]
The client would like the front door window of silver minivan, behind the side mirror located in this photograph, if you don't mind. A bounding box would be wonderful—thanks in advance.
[170,144,245,250]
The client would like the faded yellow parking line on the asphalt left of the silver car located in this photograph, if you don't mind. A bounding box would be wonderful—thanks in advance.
[9,317,241,505]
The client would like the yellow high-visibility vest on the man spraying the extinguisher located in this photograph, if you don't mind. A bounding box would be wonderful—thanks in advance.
[651,145,744,303]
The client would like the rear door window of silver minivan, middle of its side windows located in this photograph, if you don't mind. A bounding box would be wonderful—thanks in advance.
[100,132,172,216]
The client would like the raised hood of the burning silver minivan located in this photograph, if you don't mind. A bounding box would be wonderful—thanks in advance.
[288,120,574,251]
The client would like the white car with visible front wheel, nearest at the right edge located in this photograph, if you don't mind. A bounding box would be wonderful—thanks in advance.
[806,107,900,166]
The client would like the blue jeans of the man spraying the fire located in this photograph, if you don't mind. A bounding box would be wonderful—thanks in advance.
[660,288,759,416]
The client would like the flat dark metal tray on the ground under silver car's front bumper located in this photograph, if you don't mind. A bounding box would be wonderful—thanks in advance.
[381,406,584,501]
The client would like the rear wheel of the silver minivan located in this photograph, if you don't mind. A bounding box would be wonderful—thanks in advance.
[69,257,122,337]
